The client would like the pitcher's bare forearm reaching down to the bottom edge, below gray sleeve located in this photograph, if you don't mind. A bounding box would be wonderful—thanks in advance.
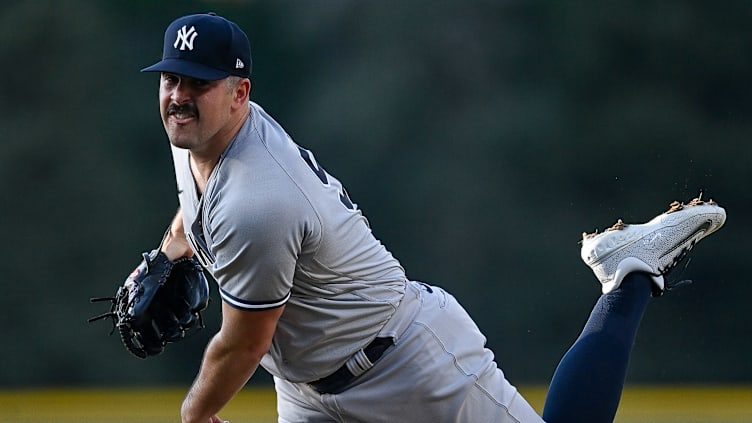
[181,332,261,423]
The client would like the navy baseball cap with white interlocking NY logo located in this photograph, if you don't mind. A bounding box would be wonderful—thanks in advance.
[141,13,251,81]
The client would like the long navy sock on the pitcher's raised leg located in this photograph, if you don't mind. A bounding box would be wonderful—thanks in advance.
[543,273,652,423]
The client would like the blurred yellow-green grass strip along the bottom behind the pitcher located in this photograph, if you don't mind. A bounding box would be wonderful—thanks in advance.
[0,386,752,423]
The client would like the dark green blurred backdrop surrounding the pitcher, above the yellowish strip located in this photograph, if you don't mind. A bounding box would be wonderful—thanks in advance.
[0,0,752,389]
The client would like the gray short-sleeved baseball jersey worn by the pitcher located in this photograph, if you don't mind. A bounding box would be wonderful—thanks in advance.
[172,103,407,382]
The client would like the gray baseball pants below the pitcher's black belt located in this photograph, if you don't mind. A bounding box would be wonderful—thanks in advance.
[275,282,543,423]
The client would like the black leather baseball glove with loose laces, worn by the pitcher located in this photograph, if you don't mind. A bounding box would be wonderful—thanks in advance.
[89,250,209,358]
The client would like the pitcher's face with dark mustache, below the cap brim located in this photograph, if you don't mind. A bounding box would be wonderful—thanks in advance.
[159,73,233,153]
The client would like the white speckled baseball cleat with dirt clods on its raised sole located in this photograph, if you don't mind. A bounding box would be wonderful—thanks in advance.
[581,197,726,295]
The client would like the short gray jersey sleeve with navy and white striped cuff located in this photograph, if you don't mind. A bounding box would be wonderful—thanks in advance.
[207,182,311,310]
